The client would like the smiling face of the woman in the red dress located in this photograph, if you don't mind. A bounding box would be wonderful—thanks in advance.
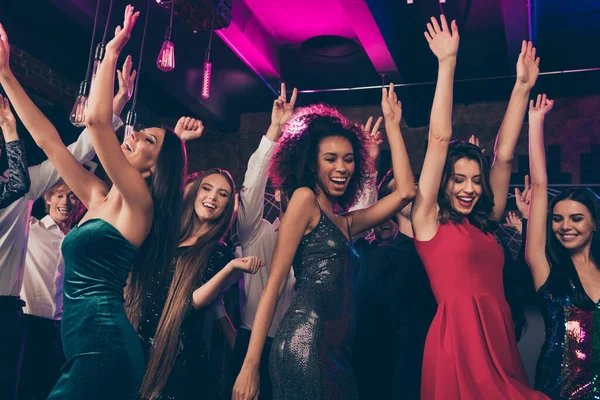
[446,158,482,215]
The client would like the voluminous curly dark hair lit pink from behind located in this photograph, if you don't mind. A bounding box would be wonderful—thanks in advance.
[269,104,369,211]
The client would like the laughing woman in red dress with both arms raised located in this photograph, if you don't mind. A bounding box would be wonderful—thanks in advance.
[412,15,547,400]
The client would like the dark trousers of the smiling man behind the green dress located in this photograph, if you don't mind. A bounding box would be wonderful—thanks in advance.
[19,314,65,400]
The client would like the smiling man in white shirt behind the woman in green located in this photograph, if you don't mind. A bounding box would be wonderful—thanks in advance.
[19,182,81,400]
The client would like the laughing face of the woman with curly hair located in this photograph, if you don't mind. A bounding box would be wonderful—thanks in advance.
[317,136,355,197]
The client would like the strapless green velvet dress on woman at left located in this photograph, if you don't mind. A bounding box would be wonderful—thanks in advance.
[49,219,144,400]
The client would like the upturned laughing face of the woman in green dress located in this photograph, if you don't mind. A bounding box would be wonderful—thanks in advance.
[121,128,166,176]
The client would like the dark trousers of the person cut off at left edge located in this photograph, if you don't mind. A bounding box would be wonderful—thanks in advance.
[0,296,25,400]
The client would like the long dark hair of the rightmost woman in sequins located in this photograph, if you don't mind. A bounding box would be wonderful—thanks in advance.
[546,188,600,309]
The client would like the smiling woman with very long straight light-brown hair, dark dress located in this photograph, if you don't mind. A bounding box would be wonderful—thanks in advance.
[127,169,261,400]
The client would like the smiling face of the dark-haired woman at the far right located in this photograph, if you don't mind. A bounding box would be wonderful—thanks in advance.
[552,199,596,250]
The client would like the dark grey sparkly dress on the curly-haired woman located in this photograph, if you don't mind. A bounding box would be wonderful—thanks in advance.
[269,211,359,400]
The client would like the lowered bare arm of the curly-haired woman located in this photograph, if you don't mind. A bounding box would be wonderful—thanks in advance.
[232,187,320,400]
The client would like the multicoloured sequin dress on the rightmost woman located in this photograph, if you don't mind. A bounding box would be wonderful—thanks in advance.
[535,273,600,400]
